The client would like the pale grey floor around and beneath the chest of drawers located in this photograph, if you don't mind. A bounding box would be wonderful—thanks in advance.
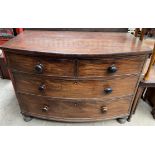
[0,79,155,126]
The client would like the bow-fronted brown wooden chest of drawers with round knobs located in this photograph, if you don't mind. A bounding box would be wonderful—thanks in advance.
[1,31,151,123]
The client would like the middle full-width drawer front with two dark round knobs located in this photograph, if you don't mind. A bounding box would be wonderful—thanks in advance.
[14,73,138,98]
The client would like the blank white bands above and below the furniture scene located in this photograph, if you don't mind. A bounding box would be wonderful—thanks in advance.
[0,0,155,155]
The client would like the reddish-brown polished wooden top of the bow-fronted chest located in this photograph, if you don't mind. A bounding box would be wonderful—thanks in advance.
[1,30,152,56]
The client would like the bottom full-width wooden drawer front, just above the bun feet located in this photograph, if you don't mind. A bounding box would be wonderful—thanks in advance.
[19,94,131,119]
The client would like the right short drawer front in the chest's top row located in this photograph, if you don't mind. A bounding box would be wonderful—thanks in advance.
[78,56,145,77]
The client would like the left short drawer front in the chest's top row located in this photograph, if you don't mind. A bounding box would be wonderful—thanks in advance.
[7,53,74,77]
